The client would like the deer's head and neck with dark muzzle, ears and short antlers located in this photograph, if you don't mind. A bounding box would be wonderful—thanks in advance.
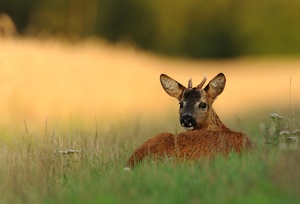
[160,73,226,130]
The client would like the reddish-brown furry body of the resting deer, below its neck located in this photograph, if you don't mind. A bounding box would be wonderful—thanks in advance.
[127,130,253,168]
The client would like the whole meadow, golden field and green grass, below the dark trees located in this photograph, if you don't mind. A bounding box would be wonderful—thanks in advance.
[0,39,300,203]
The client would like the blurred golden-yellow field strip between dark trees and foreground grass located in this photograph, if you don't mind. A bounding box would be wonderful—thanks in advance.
[0,39,300,134]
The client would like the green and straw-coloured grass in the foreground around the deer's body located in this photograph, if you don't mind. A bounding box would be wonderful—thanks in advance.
[0,114,300,203]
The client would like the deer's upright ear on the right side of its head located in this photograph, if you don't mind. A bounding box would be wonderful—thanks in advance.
[204,73,226,100]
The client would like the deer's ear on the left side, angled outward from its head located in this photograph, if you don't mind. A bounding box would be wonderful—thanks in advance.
[160,74,186,100]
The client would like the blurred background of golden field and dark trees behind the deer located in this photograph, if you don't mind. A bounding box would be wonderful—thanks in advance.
[0,0,300,137]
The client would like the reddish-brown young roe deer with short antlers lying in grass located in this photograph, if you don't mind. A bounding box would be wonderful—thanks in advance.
[126,73,253,169]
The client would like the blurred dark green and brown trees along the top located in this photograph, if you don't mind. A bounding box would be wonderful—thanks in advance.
[0,0,300,58]
